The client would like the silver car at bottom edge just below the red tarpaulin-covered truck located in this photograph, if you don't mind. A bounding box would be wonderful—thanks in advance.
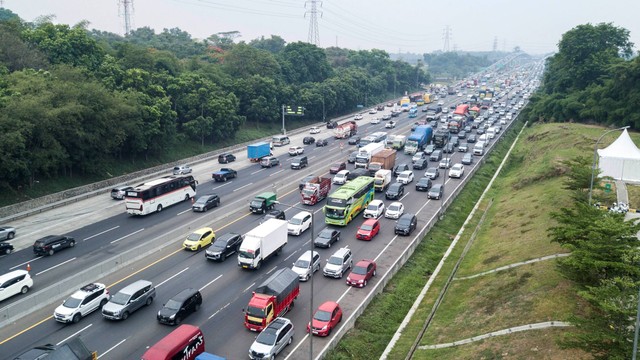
[249,317,295,359]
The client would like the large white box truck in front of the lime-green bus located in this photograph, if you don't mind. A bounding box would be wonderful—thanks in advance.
[238,219,288,269]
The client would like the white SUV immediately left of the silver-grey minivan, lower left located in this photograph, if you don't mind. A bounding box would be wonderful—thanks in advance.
[53,283,111,323]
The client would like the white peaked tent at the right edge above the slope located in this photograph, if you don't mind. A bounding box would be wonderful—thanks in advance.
[598,129,640,182]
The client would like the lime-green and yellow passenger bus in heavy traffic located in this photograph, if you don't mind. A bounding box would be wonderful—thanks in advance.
[323,176,374,226]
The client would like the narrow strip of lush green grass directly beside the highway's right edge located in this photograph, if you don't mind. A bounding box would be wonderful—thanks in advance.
[327,122,522,359]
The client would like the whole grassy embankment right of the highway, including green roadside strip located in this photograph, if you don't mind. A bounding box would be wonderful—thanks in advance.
[328,124,640,359]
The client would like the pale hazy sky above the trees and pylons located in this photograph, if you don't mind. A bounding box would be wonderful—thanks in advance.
[5,0,640,54]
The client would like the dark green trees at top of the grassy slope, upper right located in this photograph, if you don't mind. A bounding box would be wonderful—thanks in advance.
[525,23,640,129]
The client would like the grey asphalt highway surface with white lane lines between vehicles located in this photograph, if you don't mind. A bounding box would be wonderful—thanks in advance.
[0,60,540,359]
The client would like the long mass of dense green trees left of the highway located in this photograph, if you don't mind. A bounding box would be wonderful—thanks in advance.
[0,9,429,191]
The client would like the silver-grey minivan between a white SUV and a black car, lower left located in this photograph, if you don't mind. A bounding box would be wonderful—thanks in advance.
[102,280,156,320]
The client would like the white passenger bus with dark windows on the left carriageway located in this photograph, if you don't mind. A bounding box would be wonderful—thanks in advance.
[125,175,196,215]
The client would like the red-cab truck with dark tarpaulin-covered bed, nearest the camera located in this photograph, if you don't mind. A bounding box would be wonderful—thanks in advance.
[244,268,300,332]
